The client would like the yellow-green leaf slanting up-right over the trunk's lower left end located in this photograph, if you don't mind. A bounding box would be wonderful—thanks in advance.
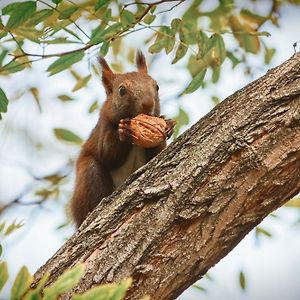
[43,264,84,300]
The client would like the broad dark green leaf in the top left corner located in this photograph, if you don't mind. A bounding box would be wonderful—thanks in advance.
[2,1,36,29]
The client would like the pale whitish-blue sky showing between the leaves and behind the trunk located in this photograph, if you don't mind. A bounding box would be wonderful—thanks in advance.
[0,1,300,300]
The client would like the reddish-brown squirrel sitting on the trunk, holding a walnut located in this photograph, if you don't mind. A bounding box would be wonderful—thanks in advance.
[71,51,173,227]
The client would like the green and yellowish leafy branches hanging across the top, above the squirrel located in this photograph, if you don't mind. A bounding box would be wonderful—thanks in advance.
[0,0,290,112]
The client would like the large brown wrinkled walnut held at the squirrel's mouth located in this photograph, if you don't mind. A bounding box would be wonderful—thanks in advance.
[130,114,175,148]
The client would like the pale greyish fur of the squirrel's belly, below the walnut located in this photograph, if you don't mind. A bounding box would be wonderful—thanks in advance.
[110,145,147,188]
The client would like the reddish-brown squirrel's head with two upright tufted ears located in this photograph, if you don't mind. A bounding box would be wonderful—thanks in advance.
[99,51,159,120]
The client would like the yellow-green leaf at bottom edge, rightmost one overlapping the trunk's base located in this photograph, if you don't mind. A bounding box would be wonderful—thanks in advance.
[72,278,132,300]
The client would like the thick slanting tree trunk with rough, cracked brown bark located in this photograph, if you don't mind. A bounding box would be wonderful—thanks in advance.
[35,53,300,299]
